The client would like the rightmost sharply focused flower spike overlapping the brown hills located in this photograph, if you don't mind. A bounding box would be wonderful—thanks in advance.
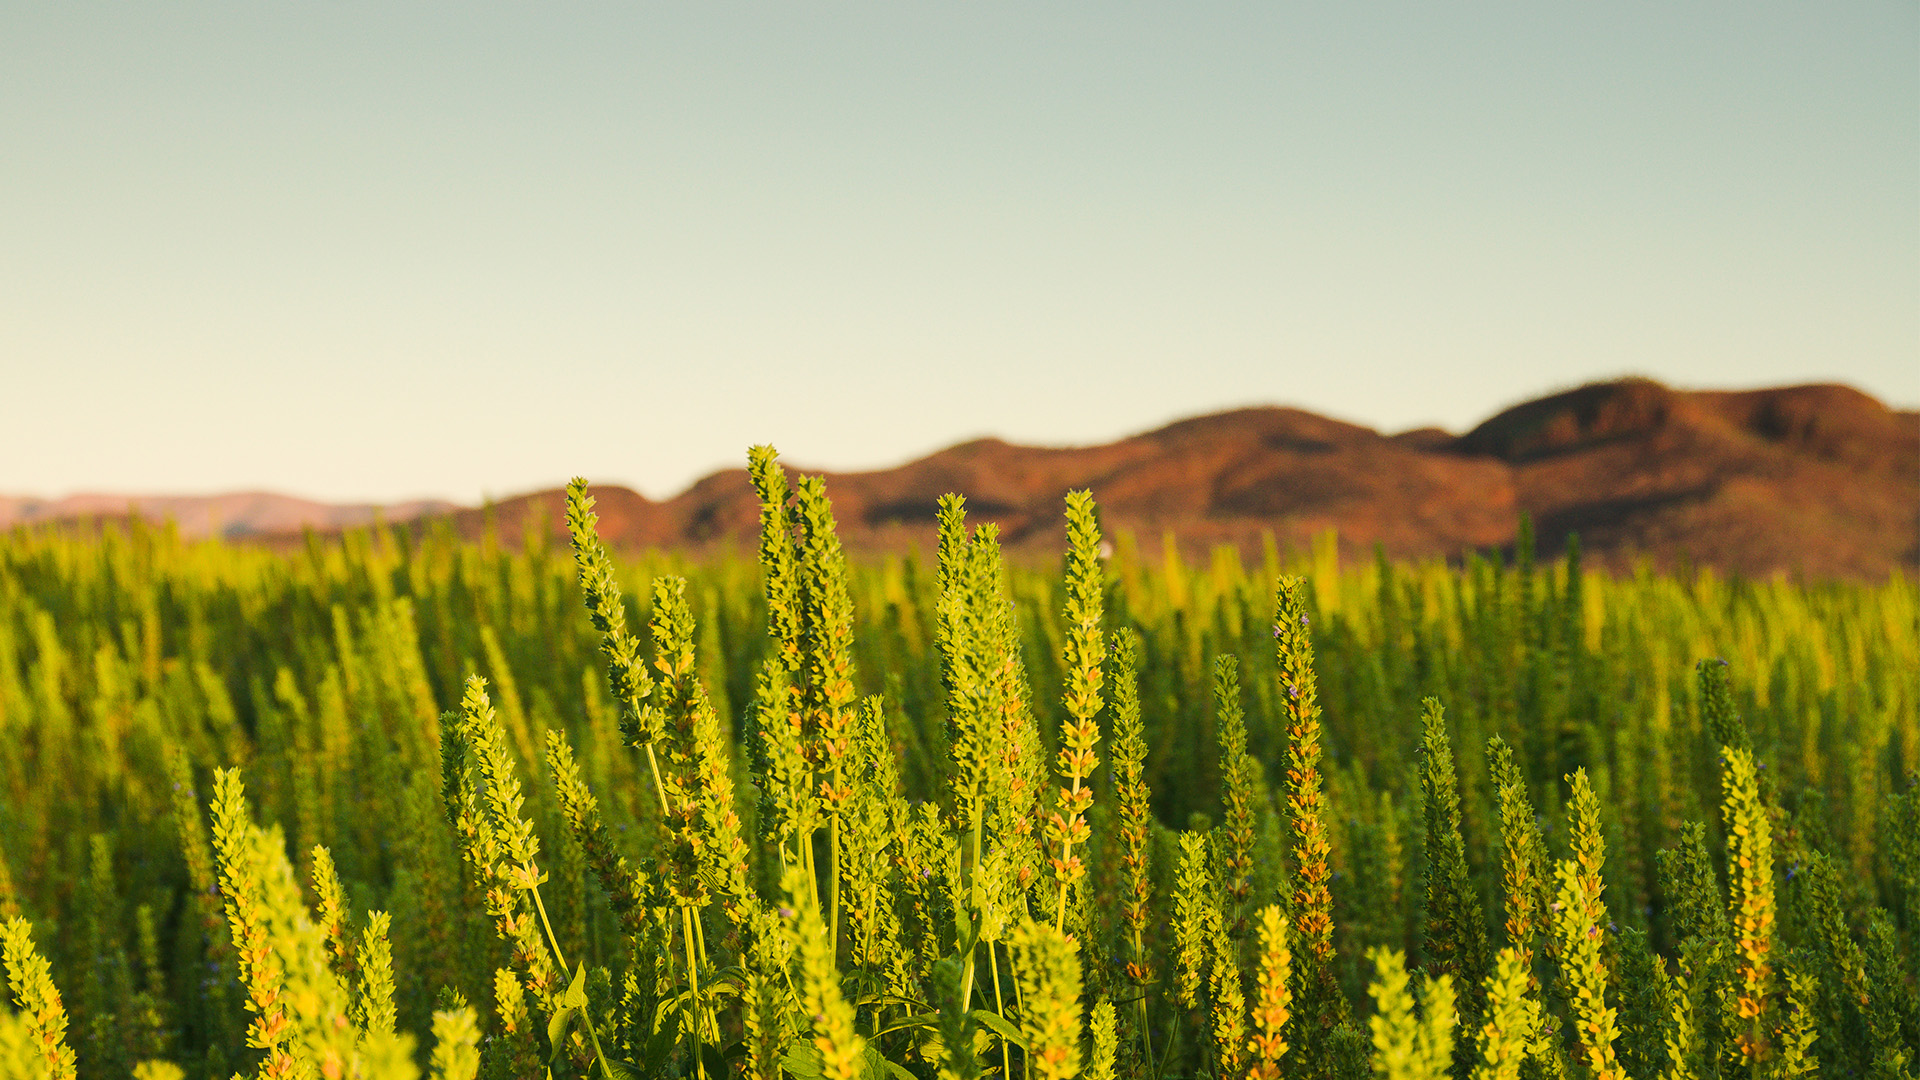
[1046,492,1106,930]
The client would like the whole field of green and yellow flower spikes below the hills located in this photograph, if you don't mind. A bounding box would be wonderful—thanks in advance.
[0,448,1920,1080]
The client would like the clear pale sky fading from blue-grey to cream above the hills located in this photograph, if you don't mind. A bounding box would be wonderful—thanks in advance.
[0,0,1920,502]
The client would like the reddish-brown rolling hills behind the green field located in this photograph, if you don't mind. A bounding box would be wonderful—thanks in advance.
[424,379,1920,577]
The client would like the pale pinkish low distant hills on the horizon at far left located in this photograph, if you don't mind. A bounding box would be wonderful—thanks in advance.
[0,492,459,540]
